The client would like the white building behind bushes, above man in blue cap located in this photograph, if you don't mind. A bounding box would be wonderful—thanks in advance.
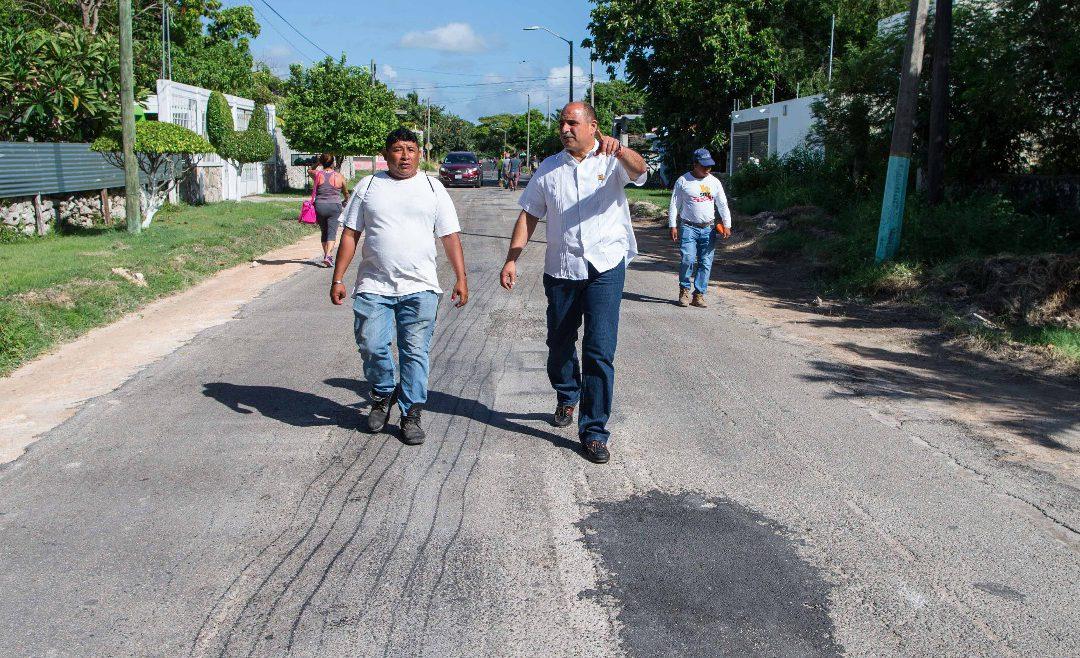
[728,94,822,174]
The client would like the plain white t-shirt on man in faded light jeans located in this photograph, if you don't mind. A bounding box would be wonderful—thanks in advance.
[342,172,461,297]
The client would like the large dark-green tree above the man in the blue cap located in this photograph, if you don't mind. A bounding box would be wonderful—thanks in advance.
[589,0,903,171]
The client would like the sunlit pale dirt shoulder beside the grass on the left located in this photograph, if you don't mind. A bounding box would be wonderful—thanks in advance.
[0,234,319,464]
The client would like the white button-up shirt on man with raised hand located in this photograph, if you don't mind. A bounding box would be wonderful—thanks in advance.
[518,142,648,281]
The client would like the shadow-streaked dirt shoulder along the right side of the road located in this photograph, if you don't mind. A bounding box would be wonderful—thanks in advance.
[634,212,1080,484]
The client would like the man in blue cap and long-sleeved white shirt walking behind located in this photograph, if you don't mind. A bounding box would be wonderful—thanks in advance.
[667,148,731,308]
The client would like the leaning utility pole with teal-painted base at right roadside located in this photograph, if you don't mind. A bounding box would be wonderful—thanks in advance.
[874,0,928,263]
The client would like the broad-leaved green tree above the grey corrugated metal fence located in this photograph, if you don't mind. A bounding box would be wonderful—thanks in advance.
[0,26,147,142]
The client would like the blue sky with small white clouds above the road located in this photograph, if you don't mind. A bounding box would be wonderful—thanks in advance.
[224,0,626,121]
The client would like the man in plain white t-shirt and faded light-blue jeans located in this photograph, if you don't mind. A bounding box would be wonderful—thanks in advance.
[330,129,469,445]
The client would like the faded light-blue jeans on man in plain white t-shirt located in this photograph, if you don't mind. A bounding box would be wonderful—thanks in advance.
[352,291,438,414]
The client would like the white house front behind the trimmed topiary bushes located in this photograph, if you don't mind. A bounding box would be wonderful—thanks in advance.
[144,80,283,202]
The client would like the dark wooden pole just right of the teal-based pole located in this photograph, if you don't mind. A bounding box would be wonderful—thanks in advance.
[927,0,953,205]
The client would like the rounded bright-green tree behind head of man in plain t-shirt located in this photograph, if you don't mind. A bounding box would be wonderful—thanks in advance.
[282,56,397,158]
